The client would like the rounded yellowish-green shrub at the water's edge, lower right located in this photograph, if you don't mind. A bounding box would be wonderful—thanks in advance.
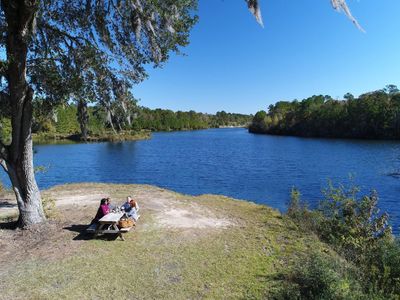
[317,184,392,263]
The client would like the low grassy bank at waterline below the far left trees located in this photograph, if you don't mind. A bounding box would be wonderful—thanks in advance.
[32,130,151,144]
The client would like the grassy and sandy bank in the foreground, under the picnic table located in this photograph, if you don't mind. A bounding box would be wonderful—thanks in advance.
[0,184,334,299]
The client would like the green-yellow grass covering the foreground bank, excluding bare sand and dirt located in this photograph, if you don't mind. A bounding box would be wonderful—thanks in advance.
[0,185,330,299]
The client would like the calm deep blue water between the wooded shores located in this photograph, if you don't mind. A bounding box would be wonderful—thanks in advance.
[2,129,400,231]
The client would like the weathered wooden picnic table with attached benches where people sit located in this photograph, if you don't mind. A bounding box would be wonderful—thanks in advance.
[86,212,133,241]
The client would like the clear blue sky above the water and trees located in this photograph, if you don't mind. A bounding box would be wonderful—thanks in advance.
[133,0,400,114]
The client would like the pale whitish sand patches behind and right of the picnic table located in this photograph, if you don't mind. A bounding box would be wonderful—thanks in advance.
[0,186,233,229]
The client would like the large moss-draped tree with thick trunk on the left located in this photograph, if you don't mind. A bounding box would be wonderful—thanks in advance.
[0,0,197,226]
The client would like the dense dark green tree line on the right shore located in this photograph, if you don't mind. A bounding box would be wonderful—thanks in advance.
[249,85,400,139]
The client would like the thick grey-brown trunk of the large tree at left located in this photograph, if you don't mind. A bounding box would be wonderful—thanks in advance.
[0,1,45,227]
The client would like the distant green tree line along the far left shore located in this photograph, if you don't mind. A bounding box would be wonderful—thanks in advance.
[0,99,252,140]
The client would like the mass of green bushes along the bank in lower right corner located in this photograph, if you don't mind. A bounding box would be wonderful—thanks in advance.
[287,180,400,299]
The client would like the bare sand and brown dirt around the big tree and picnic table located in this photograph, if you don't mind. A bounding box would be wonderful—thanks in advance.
[0,184,234,264]
